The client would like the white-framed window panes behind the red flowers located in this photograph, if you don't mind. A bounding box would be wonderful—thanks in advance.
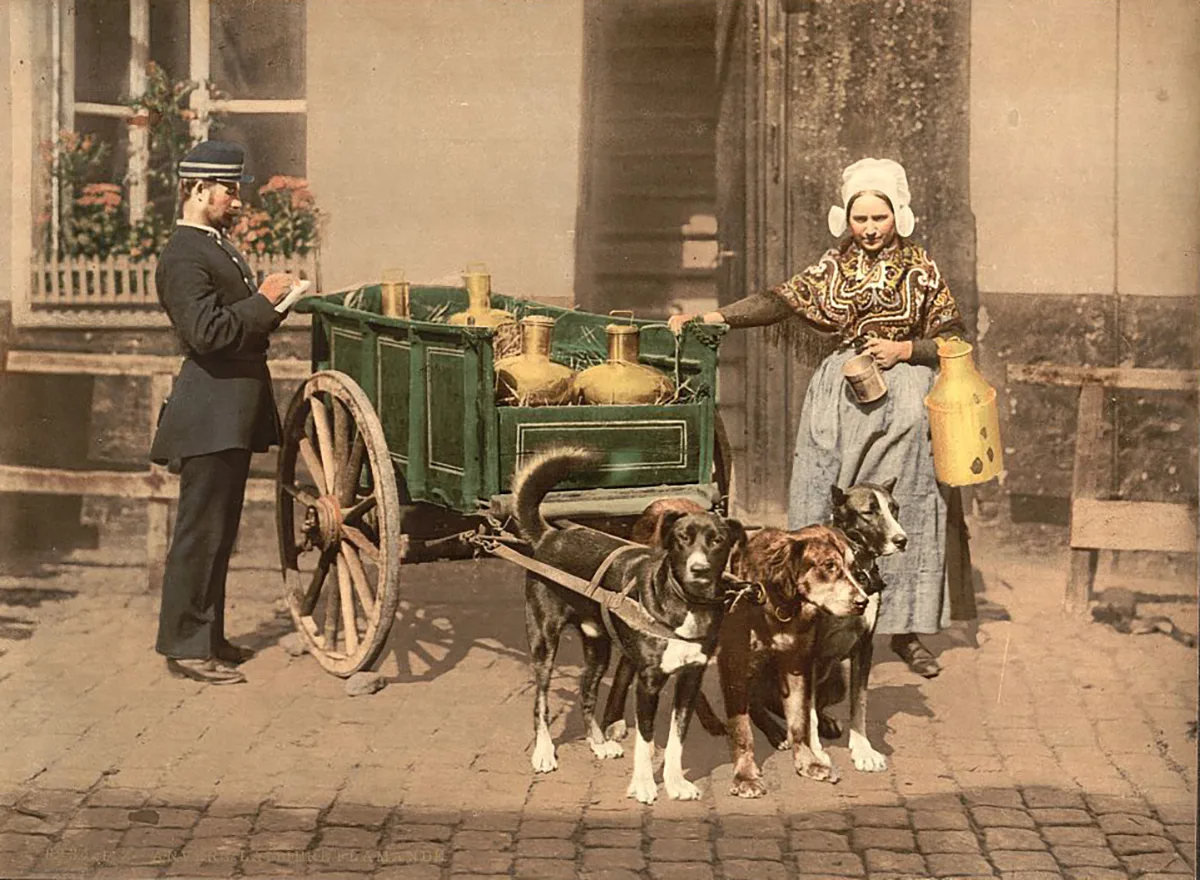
[50,0,307,240]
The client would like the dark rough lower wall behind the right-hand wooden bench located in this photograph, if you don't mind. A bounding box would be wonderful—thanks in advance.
[979,293,1200,521]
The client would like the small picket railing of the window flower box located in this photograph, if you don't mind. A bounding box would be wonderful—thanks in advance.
[30,251,317,311]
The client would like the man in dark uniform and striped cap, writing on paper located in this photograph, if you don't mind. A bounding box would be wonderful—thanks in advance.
[150,140,294,684]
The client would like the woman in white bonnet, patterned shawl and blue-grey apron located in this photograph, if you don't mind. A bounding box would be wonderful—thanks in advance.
[671,158,973,678]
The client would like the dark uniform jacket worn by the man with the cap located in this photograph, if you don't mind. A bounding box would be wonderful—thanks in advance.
[150,226,282,465]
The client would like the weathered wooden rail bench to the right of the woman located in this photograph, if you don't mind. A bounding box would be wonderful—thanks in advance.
[1008,364,1200,613]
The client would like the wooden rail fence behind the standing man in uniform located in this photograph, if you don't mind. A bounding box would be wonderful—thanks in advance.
[0,351,312,589]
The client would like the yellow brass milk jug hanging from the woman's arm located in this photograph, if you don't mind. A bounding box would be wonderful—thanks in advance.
[925,339,1004,486]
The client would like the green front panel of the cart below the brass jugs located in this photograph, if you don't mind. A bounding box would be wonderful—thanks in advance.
[499,403,712,491]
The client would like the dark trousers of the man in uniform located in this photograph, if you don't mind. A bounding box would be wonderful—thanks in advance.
[155,449,250,659]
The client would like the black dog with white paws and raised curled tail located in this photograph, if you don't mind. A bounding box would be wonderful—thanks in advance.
[512,449,745,803]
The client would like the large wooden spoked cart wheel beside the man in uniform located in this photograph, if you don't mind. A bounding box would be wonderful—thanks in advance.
[276,370,403,676]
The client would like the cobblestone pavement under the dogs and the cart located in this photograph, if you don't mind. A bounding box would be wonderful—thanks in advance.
[0,513,1196,880]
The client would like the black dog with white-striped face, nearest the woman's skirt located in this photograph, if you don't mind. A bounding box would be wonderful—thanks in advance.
[698,479,908,772]
